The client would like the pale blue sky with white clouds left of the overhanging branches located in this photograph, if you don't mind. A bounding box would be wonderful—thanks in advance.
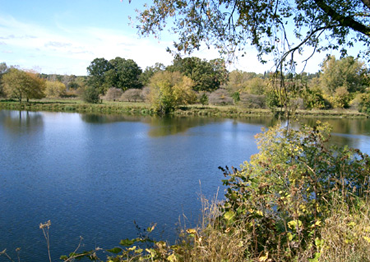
[0,0,364,75]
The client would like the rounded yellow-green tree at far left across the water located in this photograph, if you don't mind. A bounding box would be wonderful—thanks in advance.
[2,68,46,102]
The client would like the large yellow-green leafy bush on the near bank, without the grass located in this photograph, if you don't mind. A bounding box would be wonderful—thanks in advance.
[220,123,370,261]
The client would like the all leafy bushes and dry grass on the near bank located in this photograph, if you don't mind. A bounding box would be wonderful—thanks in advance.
[59,122,370,261]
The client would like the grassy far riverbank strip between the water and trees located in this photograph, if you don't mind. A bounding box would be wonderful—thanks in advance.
[0,99,369,118]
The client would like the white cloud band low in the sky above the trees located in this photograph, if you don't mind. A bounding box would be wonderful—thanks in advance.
[0,15,330,75]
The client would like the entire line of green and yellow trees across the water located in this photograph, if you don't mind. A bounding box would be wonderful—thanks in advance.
[0,56,370,113]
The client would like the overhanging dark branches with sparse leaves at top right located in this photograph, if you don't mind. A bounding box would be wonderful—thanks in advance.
[137,0,370,113]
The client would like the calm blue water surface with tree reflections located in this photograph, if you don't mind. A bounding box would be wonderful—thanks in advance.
[0,111,370,261]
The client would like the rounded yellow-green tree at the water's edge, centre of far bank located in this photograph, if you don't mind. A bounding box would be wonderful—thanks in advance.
[149,71,196,114]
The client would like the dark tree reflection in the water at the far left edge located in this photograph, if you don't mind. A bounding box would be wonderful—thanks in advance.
[0,110,44,132]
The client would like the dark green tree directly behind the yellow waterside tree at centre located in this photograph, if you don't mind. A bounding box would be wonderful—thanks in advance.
[167,56,228,91]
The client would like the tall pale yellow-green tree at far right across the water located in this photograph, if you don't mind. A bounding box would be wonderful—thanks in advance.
[320,56,368,95]
